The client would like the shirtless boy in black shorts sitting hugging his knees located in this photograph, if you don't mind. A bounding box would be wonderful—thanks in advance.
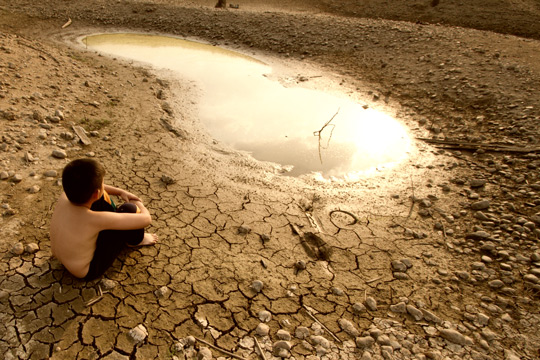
[50,159,158,281]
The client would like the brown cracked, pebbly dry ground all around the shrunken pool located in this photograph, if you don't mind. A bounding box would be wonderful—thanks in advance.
[0,1,540,359]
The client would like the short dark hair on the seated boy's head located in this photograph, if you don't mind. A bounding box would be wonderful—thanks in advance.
[62,159,105,205]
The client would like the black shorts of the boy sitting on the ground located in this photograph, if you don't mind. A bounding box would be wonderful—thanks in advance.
[84,197,144,281]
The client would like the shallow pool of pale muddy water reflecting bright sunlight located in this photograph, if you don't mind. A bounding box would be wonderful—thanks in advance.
[82,34,411,179]
